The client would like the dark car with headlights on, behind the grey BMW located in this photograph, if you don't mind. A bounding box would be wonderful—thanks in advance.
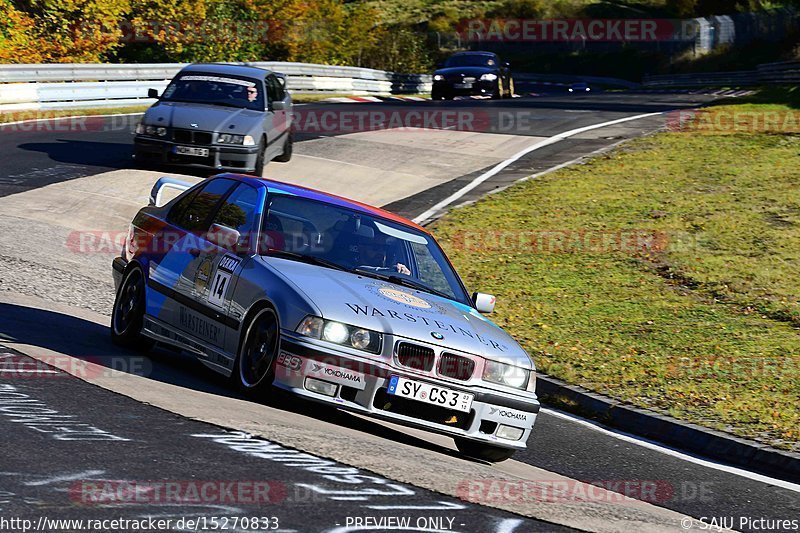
[431,52,514,100]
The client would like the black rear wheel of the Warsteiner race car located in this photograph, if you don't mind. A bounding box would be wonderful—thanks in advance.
[111,267,155,351]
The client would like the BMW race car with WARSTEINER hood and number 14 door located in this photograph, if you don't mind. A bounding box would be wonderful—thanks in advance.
[111,174,539,461]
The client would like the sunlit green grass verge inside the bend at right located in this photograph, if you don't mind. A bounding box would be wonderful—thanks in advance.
[433,104,800,449]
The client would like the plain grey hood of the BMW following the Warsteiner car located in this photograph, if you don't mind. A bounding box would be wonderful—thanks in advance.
[142,102,263,135]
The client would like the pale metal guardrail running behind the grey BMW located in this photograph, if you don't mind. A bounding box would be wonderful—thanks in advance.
[0,61,431,111]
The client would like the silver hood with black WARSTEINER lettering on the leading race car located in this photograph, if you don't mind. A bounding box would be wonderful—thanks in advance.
[262,257,533,368]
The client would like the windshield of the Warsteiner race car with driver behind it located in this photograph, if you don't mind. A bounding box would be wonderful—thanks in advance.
[264,195,470,305]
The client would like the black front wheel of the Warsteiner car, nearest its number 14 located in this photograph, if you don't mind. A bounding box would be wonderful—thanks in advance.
[231,306,281,399]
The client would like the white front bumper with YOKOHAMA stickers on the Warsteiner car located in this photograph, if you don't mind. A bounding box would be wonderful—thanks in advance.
[275,332,539,449]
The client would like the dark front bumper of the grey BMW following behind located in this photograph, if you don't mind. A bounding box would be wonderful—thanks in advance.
[133,135,259,172]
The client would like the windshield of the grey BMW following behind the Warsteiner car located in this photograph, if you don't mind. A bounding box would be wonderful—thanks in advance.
[161,73,264,111]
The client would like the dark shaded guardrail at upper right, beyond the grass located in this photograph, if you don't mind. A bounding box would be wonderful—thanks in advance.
[642,61,800,88]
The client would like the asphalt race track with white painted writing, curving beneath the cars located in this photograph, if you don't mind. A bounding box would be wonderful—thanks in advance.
[0,93,800,532]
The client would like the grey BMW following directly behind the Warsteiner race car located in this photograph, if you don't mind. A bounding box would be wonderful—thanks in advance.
[133,64,293,176]
